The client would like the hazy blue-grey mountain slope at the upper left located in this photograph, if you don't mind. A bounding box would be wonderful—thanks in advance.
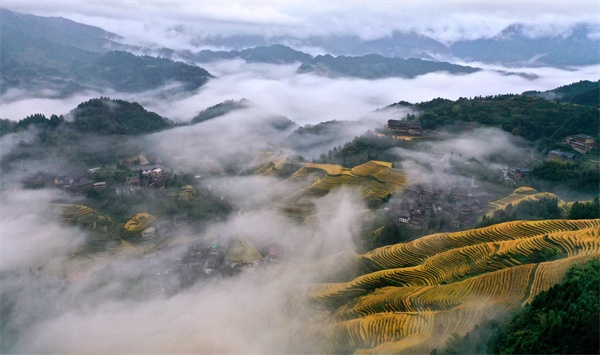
[0,9,212,96]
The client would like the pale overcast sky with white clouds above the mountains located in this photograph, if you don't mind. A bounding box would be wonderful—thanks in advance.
[0,0,600,49]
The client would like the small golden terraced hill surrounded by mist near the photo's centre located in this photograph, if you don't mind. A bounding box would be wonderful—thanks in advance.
[271,160,406,203]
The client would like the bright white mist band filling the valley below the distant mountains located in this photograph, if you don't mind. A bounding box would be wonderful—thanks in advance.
[0,60,598,125]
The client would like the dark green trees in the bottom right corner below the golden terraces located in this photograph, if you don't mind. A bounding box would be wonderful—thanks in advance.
[490,259,600,354]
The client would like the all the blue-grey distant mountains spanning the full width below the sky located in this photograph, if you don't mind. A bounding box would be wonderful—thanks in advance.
[0,9,600,95]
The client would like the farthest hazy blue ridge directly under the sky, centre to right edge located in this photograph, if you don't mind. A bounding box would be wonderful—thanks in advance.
[185,24,600,67]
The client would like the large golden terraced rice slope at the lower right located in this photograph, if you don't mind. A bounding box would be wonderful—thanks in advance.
[297,219,600,354]
